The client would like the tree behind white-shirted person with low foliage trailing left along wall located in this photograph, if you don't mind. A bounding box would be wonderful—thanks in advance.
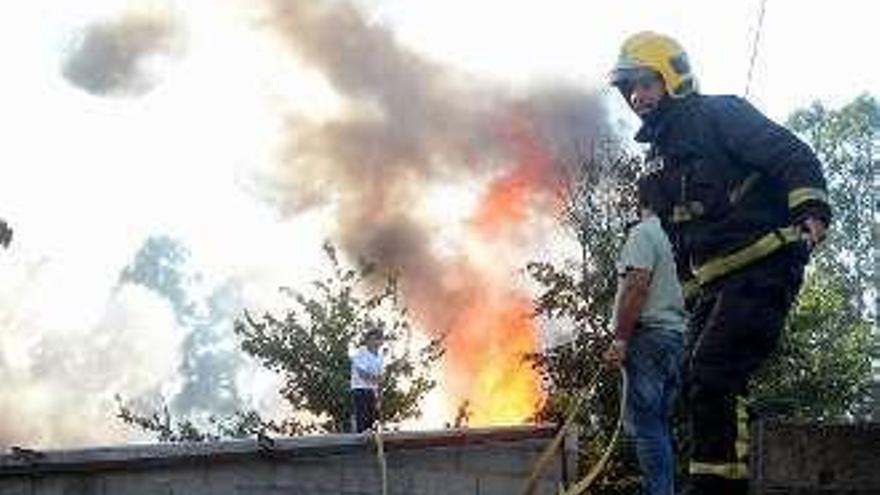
[119,244,442,441]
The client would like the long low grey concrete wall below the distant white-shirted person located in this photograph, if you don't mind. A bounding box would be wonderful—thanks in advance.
[0,426,574,495]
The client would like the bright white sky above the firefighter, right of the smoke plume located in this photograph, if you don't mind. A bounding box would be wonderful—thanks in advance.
[382,0,880,119]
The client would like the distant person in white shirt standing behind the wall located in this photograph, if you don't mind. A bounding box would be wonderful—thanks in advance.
[351,327,384,433]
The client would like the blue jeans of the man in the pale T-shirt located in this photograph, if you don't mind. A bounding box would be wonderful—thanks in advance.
[624,327,684,495]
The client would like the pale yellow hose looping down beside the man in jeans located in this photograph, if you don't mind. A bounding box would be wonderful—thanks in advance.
[522,368,627,495]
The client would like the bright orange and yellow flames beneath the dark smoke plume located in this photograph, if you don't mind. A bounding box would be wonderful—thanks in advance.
[447,114,553,426]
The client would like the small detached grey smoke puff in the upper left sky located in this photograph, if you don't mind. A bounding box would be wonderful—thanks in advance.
[61,12,182,96]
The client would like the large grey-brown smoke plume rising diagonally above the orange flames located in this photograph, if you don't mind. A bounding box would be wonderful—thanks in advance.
[260,0,606,338]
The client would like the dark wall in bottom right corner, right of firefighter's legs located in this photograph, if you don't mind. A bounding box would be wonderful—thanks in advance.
[752,420,880,495]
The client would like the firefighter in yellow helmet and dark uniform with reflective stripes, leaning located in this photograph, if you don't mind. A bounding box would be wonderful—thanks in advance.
[611,32,831,495]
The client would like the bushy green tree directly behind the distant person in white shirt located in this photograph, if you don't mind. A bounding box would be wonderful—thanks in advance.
[235,245,441,432]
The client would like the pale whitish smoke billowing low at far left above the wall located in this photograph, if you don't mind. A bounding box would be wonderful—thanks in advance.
[0,272,181,451]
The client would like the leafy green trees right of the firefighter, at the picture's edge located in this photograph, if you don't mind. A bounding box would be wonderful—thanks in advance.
[755,95,880,419]
